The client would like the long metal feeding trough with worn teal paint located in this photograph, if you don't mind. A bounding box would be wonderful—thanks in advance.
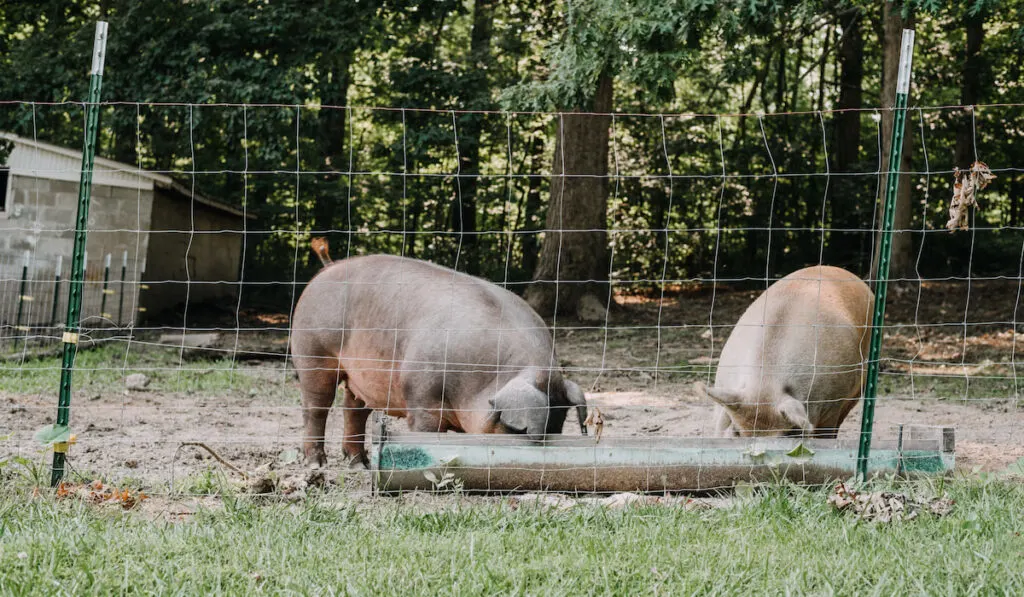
[370,417,954,494]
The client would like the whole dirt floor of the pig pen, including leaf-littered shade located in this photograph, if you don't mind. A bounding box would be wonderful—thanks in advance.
[0,283,1024,489]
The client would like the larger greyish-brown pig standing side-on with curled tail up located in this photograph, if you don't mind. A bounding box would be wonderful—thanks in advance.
[292,244,587,465]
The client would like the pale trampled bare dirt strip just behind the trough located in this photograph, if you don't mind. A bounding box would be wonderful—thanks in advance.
[0,385,1024,488]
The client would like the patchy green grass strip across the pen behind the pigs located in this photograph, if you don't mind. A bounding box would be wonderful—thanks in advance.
[0,329,1020,401]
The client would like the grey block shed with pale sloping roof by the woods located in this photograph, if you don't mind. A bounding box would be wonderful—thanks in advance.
[0,132,247,327]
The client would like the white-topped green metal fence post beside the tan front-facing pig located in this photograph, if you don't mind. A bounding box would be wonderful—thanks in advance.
[857,29,913,480]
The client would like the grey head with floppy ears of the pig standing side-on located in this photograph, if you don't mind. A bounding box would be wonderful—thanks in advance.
[490,370,587,439]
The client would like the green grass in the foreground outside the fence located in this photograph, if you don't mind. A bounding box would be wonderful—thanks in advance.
[0,479,1024,596]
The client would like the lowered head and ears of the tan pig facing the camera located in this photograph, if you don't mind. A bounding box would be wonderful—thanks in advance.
[696,383,814,437]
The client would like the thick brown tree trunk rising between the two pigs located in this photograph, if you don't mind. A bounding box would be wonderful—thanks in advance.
[525,74,612,316]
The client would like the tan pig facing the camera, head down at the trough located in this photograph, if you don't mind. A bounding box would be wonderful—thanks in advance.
[698,265,874,437]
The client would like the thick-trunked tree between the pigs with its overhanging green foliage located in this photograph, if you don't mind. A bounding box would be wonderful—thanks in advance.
[504,0,714,316]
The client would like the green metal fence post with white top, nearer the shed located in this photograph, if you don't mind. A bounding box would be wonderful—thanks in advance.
[50,20,106,486]
